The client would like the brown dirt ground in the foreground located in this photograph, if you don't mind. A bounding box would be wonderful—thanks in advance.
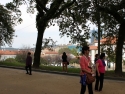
[0,68,125,94]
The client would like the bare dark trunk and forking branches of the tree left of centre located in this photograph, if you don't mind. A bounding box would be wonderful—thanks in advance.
[34,0,75,67]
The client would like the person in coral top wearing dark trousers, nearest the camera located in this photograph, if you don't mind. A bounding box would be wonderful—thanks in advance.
[80,46,94,94]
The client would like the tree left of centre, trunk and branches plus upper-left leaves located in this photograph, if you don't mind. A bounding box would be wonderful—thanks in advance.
[10,0,76,68]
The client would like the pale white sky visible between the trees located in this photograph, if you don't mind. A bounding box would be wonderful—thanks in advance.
[0,0,95,48]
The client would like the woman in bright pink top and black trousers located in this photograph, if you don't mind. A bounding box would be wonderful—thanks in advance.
[95,53,106,91]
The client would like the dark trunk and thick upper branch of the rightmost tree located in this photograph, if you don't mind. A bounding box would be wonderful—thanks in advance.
[97,0,125,75]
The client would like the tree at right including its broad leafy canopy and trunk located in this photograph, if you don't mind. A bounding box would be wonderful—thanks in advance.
[60,0,125,74]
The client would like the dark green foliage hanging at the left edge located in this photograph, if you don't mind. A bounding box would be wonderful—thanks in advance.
[0,5,14,45]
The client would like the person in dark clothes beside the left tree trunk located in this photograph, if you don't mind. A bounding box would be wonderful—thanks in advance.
[25,52,32,75]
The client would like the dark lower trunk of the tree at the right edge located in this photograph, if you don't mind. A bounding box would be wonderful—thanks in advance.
[115,22,125,75]
